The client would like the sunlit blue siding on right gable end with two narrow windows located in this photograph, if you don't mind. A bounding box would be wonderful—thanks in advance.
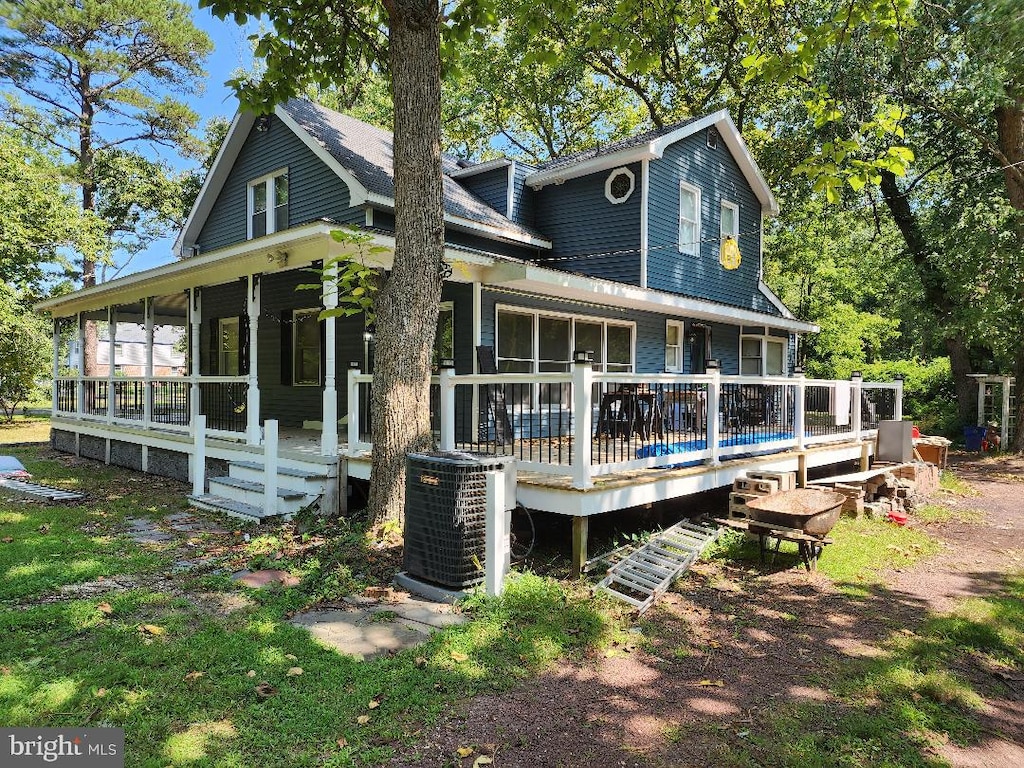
[647,132,779,314]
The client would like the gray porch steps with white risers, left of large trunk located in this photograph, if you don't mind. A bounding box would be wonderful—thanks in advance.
[188,462,328,522]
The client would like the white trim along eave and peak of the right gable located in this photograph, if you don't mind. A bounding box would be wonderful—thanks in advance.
[526,110,778,216]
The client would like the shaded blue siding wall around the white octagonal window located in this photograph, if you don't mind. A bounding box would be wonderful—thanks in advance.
[535,163,641,286]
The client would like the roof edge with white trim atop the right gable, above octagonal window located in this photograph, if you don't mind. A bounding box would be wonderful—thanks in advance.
[526,110,778,215]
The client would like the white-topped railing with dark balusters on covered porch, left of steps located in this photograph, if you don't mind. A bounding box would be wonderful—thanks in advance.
[55,376,248,438]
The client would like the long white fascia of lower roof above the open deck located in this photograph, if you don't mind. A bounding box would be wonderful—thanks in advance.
[488,262,818,333]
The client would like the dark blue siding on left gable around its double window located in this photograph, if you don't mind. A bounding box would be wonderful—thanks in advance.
[198,119,364,252]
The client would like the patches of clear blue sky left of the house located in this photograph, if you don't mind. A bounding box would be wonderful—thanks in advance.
[118,0,256,278]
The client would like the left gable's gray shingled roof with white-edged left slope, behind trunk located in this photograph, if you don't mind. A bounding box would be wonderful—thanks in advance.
[174,99,551,255]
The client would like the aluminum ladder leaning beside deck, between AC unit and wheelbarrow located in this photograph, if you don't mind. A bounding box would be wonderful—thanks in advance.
[595,522,721,613]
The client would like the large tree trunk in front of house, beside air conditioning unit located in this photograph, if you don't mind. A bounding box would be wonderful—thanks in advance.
[370,0,444,525]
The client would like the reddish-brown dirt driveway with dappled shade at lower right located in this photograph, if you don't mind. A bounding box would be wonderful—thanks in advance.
[391,457,1024,768]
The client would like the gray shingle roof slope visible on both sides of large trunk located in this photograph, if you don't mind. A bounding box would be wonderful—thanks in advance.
[284,99,546,240]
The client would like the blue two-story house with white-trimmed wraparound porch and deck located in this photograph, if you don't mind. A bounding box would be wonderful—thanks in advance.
[41,100,899,561]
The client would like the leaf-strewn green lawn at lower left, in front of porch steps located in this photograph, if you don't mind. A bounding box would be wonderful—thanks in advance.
[0,449,621,766]
